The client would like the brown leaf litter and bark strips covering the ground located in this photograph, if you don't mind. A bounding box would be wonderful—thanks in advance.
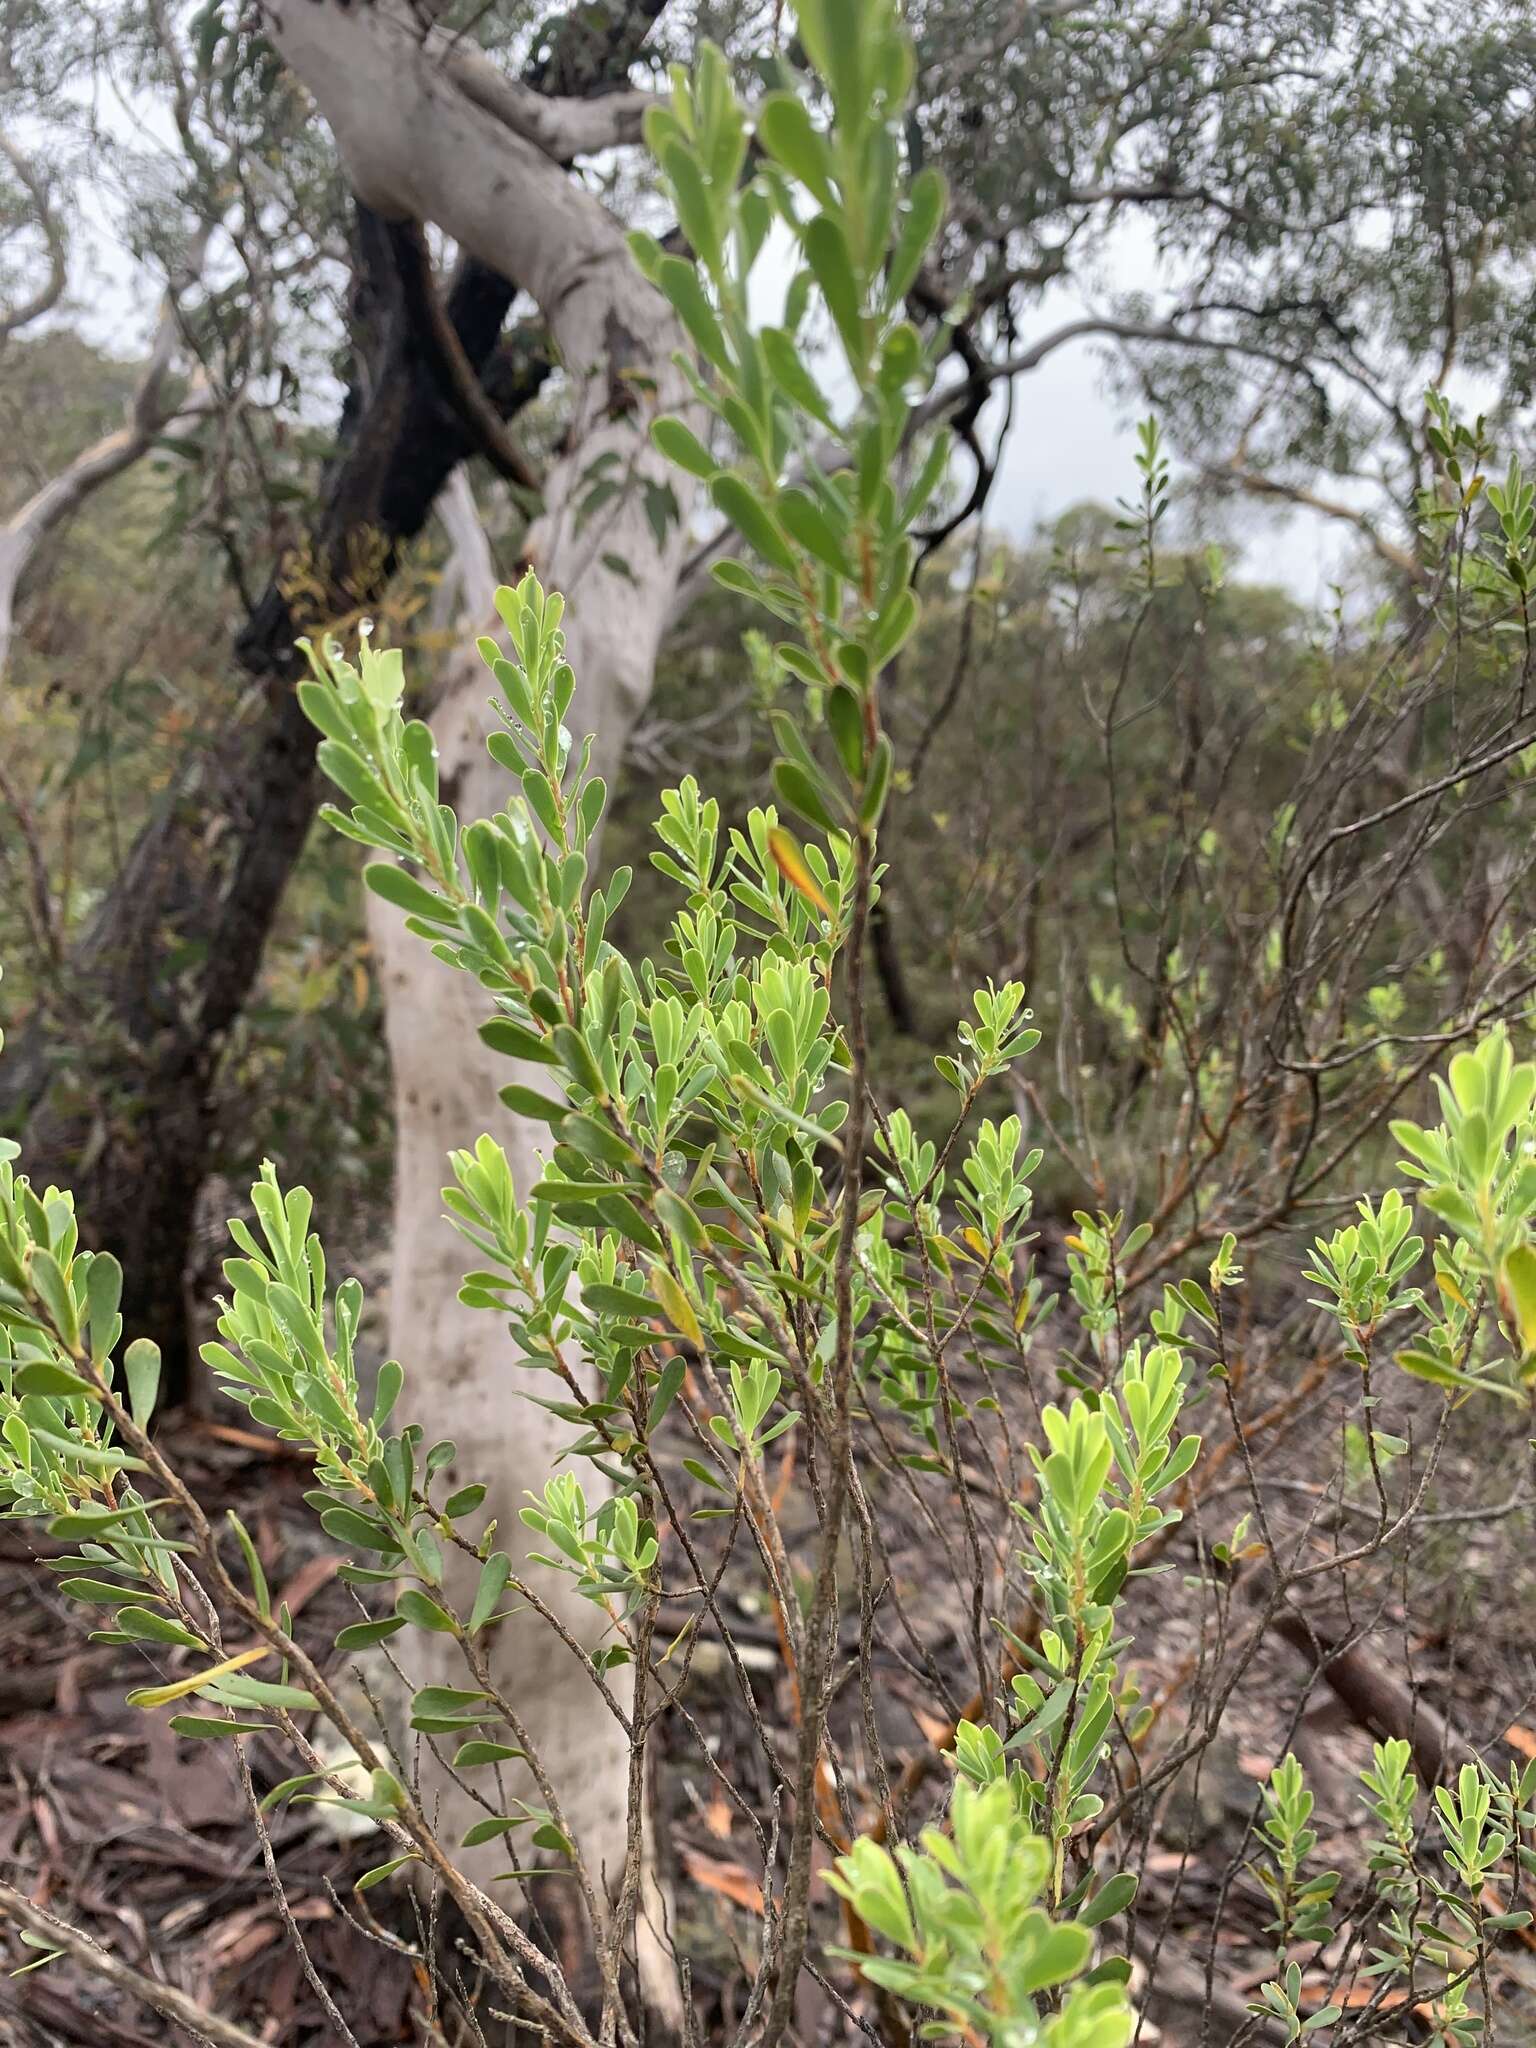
[0,1277,1536,2048]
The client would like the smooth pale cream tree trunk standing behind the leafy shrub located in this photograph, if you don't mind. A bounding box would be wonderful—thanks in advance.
[266,0,704,2003]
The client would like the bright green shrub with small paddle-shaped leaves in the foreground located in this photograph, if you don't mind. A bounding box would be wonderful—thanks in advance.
[0,0,1536,2048]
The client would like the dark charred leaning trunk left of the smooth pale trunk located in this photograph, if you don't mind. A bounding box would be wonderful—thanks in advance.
[0,232,551,1399]
